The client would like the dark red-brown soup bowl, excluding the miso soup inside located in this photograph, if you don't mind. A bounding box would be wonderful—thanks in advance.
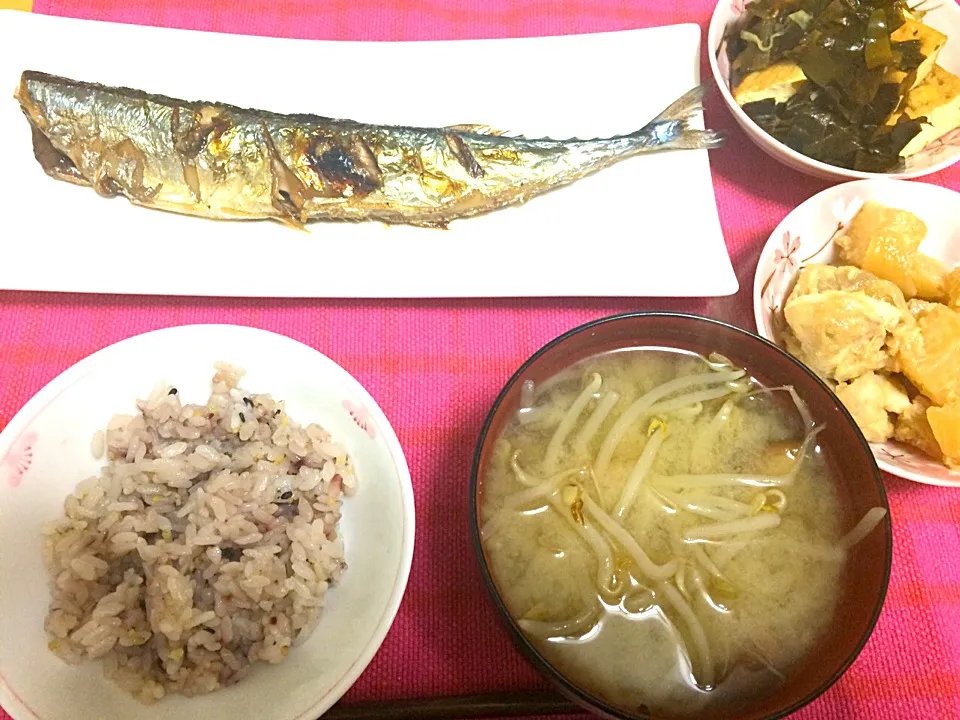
[470,313,892,720]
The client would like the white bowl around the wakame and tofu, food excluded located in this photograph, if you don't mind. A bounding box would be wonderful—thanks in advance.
[707,0,960,180]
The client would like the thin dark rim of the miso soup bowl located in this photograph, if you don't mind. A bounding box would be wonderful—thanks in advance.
[469,311,893,720]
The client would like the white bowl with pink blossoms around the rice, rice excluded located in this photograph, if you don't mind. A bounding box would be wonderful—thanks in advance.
[0,325,414,720]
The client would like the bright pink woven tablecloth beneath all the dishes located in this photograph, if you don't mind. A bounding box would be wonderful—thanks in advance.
[0,0,960,720]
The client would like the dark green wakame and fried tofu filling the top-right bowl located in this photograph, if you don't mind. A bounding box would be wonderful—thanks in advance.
[726,0,960,172]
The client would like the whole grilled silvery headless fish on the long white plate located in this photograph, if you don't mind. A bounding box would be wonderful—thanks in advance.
[15,71,723,227]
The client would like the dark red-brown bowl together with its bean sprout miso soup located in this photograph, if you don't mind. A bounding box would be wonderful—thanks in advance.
[470,313,892,720]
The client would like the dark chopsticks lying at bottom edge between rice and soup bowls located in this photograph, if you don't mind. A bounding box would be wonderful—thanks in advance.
[323,691,587,720]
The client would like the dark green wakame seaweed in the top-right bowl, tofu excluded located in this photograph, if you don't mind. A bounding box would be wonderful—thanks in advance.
[727,0,925,172]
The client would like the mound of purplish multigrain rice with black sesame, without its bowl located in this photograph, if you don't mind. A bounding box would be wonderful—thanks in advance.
[43,364,356,703]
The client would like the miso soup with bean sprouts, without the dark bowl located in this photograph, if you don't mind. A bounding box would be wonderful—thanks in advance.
[480,348,886,718]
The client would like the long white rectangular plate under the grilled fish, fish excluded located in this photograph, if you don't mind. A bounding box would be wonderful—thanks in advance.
[0,11,737,297]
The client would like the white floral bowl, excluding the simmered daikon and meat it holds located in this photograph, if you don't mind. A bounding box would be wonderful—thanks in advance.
[753,179,960,486]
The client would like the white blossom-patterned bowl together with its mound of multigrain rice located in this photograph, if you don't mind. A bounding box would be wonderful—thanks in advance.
[0,325,414,720]
